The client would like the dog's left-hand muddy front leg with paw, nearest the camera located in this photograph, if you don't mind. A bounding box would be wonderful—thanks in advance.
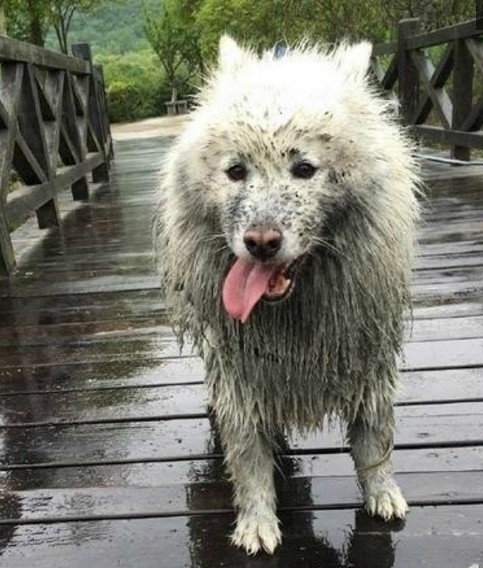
[219,414,281,554]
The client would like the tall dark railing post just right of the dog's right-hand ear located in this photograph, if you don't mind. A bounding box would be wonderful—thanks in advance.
[397,18,420,124]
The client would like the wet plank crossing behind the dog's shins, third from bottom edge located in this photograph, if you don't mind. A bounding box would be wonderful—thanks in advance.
[0,403,483,469]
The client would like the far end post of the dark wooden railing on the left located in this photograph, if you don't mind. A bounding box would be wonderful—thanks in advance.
[72,43,110,183]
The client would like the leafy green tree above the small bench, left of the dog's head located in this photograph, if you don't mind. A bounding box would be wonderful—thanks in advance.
[143,0,203,101]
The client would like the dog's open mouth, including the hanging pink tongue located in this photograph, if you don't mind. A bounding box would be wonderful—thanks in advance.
[222,257,303,323]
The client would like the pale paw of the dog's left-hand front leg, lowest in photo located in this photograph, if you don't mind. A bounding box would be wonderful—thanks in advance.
[231,515,282,554]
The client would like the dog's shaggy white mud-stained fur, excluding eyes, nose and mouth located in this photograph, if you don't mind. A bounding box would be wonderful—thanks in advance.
[155,38,418,553]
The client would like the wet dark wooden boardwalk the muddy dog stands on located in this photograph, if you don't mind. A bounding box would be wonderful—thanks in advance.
[0,137,483,568]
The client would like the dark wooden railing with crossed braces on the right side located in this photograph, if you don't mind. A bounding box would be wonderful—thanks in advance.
[372,18,483,160]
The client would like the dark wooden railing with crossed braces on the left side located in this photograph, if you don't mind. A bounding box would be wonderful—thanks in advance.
[0,36,112,276]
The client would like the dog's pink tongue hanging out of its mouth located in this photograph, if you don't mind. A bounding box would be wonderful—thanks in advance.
[222,258,277,323]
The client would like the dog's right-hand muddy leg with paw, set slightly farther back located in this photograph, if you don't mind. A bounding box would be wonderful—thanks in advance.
[348,400,408,521]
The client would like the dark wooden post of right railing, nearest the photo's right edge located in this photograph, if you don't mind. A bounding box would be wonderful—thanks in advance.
[451,39,474,160]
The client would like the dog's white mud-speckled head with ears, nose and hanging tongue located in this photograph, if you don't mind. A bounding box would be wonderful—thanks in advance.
[178,38,390,321]
